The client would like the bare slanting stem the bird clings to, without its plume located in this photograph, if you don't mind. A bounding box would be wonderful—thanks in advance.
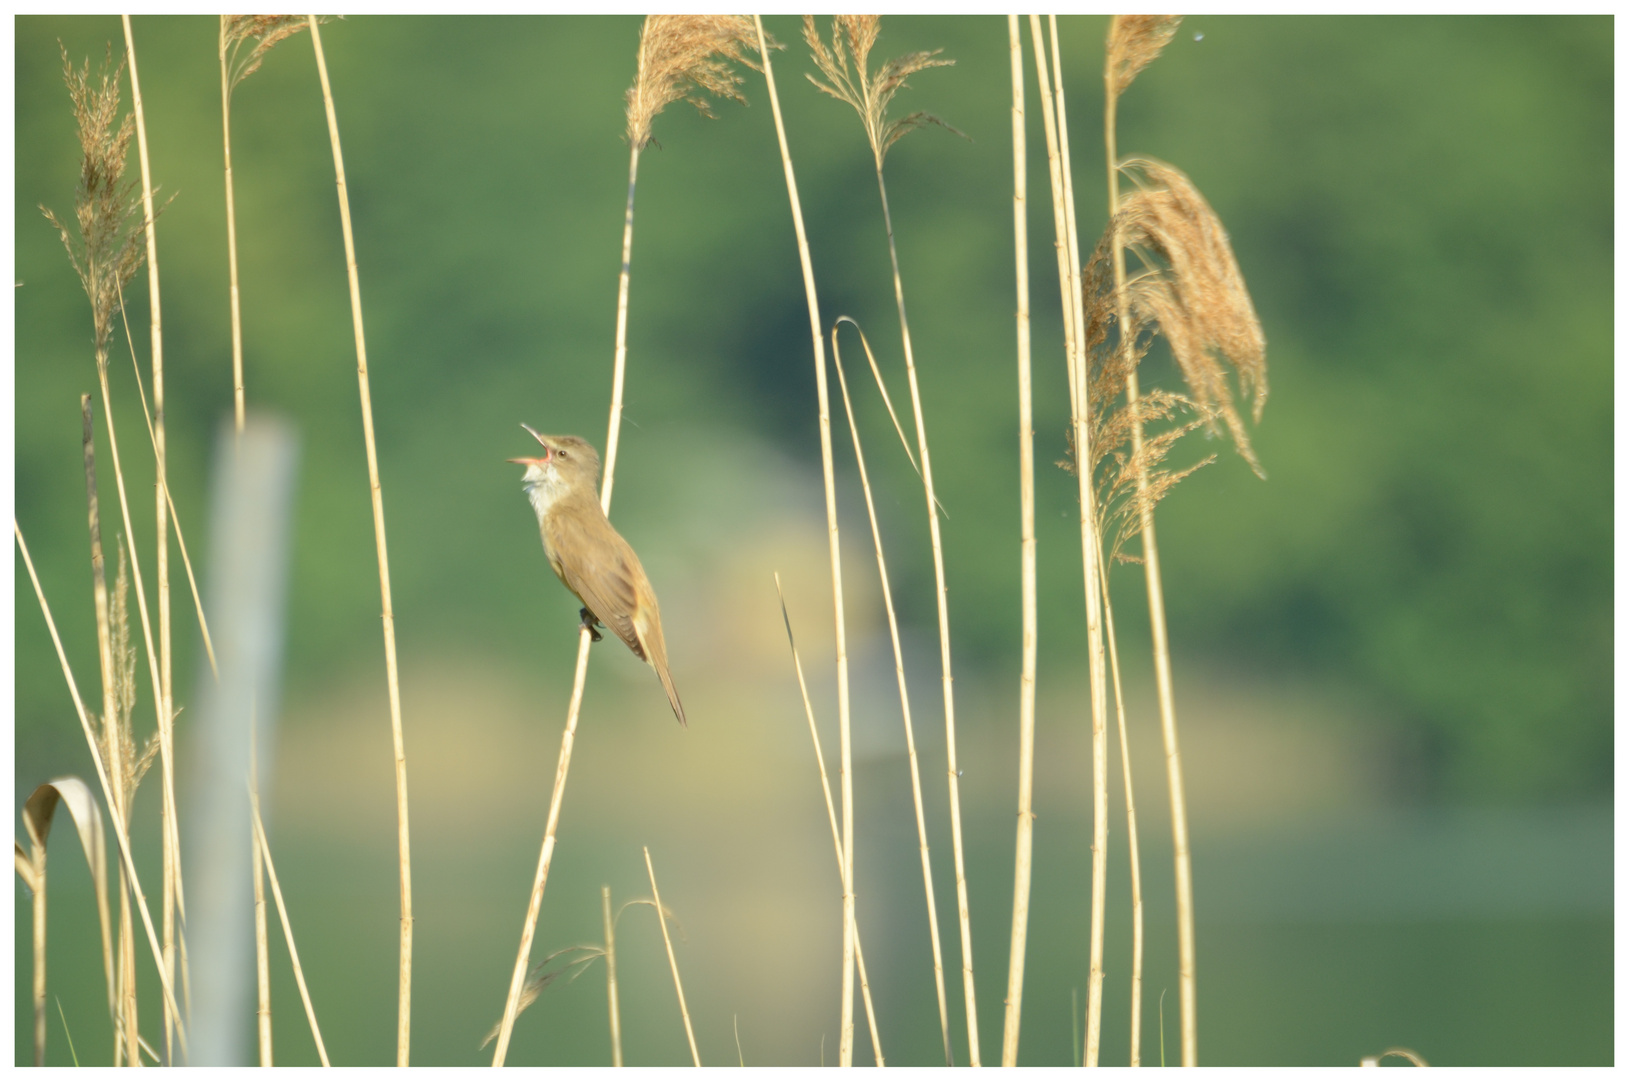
[491,94,638,1067]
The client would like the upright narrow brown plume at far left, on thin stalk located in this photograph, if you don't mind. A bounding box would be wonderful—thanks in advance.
[39,42,146,363]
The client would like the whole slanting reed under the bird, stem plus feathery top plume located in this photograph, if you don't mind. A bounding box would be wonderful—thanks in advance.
[484,15,758,1065]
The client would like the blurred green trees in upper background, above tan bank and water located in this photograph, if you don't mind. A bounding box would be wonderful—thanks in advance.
[15,16,1612,819]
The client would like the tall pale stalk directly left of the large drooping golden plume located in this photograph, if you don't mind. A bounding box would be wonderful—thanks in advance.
[1030,16,1108,1065]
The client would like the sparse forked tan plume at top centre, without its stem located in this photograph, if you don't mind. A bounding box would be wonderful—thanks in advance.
[802,15,965,169]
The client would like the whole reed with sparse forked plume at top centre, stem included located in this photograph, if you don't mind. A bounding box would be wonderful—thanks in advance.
[802,15,981,1065]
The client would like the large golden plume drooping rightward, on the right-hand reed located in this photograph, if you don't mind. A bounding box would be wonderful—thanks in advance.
[1085,158,1269,477]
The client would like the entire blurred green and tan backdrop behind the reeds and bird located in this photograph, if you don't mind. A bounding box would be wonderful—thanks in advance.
[13,16,1614,1064]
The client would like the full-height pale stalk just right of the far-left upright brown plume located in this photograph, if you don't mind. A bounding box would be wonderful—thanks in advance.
[122,15,185,1064]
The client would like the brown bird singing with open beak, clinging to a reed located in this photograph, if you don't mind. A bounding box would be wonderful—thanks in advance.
[509,425,688,727]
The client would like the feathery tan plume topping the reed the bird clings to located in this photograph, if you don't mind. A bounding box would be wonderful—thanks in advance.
[626,15,767,150]
